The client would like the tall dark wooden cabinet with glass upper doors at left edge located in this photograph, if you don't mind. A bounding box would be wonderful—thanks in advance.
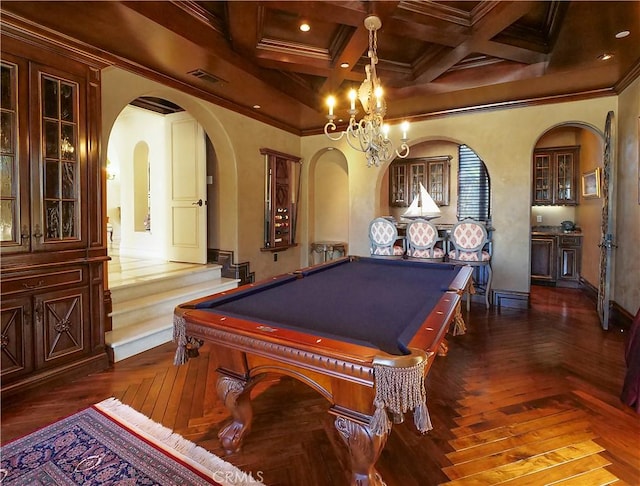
[0,28,108,398]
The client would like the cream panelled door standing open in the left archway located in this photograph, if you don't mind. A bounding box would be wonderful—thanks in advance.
[166,112,207,263]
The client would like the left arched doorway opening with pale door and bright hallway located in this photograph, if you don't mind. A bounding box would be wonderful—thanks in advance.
[107,100,208,264]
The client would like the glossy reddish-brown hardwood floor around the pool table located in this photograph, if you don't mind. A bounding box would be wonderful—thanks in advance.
[1,287,640,486]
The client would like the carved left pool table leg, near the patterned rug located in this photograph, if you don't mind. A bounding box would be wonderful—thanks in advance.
[217,375,253,454]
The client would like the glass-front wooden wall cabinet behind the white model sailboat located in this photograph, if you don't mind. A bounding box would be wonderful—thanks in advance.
[389,155,451,207]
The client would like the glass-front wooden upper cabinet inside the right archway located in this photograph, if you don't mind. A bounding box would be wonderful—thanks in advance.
[532,146,580,206]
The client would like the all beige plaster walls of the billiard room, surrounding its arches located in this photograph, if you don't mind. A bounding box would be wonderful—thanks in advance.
[102,68,640,311]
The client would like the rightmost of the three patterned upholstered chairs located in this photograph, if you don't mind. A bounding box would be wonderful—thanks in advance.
[447,219,492,310]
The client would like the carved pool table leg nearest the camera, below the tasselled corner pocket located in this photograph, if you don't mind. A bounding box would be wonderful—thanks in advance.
[335,416,387,486]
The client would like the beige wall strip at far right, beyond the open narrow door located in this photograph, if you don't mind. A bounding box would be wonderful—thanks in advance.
[612,78,640,314]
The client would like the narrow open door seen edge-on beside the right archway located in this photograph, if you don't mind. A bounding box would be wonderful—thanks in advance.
[598,111,616,330]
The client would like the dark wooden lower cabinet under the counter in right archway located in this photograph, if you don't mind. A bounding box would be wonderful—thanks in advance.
[531,234,582,287]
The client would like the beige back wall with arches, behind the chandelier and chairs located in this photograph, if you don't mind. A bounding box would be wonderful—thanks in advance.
[302,97,616,292]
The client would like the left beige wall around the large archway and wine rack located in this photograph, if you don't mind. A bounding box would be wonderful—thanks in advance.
[102,67,306,279]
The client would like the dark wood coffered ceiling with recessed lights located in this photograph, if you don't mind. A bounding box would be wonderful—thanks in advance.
[1,0,640,134]
